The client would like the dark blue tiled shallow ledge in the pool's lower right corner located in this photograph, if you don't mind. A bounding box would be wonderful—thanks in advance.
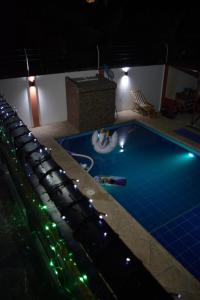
[151,205,200,280]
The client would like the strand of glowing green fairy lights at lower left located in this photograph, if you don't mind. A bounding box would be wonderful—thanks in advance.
[0,120,97,300]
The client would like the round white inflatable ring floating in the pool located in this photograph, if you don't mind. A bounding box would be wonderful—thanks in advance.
[92,128,118,154]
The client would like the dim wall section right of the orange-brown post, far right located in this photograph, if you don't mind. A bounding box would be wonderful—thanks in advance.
[165,66,197,99]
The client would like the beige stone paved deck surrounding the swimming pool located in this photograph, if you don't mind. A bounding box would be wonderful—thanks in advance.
[31,110,200,300]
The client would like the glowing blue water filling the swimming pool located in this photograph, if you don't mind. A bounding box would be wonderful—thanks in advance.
[59,123,200,279]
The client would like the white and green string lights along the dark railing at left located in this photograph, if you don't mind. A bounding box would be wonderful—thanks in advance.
[1,99,117,299]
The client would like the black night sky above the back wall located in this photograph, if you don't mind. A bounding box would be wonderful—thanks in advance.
[0,0,200,75]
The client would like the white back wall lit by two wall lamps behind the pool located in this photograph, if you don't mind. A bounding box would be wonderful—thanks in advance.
[0,65,164,127]
